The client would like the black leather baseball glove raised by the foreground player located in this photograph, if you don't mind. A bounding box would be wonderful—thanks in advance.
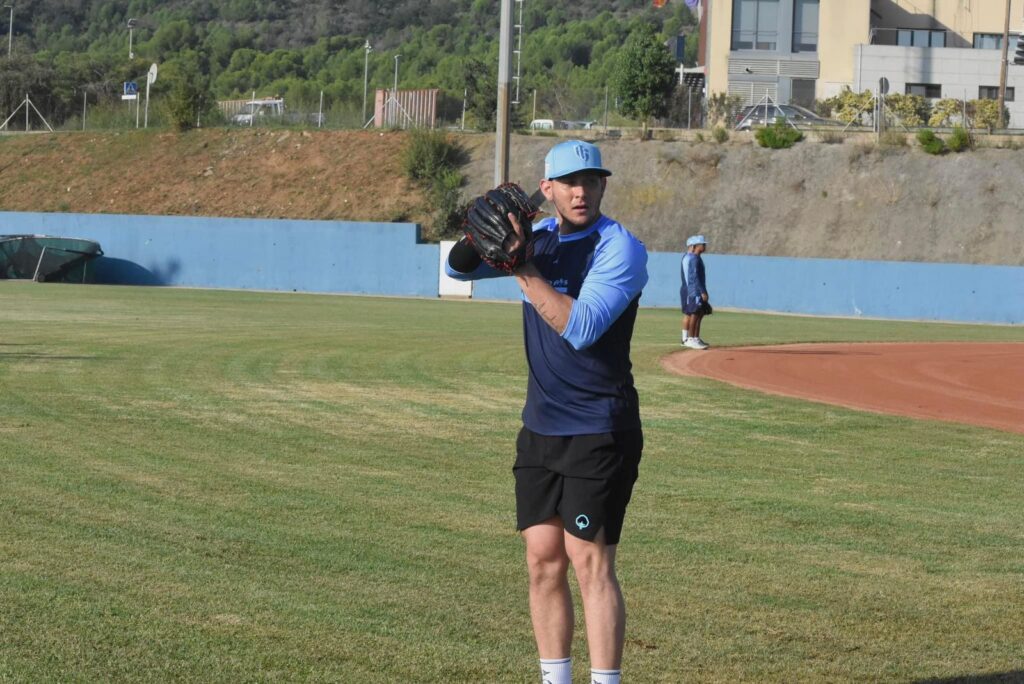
[463,183,540,273]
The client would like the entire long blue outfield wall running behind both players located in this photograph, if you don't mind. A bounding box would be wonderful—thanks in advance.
[0,212,1024,325]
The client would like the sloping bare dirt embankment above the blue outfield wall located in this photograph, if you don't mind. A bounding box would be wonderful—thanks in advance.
[0,130,1024,265]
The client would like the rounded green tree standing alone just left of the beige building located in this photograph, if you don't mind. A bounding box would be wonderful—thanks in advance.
[612,24,676,137]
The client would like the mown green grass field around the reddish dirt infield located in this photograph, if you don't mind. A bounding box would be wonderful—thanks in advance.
[0,282,1024,682]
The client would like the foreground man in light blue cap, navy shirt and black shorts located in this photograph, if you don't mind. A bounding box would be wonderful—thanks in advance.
[445,140,647,684]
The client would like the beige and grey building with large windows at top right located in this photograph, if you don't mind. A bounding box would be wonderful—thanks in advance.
[701,0,1024,116]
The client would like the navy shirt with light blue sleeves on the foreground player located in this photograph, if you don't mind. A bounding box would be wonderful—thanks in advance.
[445,216,647,435]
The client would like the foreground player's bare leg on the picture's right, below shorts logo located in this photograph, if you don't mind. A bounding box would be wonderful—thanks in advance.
[565,530,626,670]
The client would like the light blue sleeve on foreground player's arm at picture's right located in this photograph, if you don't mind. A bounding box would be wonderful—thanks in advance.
[562,231,647,349]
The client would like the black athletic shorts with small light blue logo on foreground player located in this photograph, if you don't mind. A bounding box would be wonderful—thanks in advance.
[512,427,643,544]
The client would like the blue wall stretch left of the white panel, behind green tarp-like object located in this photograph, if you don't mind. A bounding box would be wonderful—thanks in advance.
[0,212,440,297]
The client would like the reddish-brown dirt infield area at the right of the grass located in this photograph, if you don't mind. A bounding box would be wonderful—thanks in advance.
[662,342,1024,434]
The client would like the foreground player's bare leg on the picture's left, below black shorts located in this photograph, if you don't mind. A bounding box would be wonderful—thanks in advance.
[522,518,573,659]
